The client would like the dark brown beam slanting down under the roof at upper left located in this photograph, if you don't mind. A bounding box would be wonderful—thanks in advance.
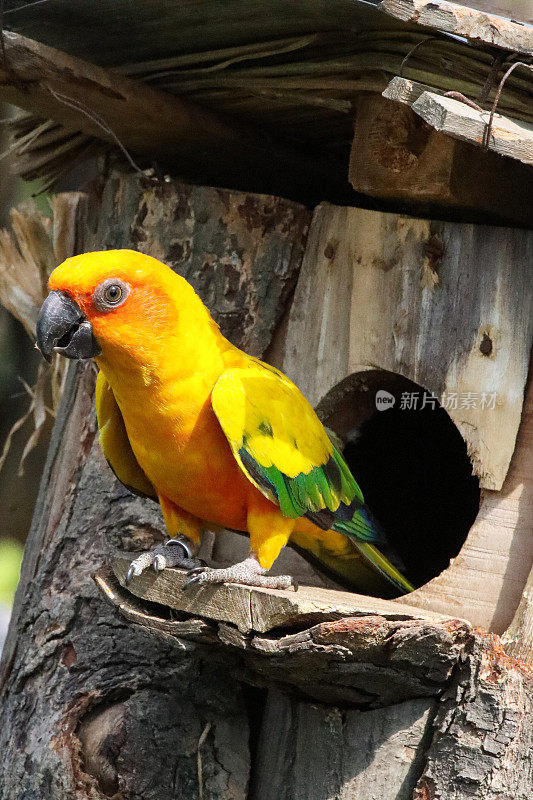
[0,31,336,203]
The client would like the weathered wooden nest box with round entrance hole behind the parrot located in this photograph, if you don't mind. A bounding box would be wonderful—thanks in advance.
[0,0,533,800]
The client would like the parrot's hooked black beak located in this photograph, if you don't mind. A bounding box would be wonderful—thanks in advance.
[37,292,102,361]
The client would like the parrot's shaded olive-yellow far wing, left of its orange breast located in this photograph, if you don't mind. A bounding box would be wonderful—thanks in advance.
[95,372,157,500]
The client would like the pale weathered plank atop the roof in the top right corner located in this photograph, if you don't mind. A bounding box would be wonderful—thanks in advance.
[378,0,533,55]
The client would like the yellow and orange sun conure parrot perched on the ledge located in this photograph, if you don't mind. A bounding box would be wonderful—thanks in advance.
[37,250,413,594]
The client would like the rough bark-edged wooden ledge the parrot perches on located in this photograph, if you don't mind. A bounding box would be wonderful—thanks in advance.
[95,557,474,707]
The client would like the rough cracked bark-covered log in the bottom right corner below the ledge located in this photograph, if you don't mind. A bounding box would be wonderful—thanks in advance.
[415,637,533,800]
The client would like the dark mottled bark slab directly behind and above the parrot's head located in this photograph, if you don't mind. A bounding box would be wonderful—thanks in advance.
[87,173,311,356]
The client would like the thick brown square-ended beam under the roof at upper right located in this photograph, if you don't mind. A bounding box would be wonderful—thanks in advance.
[349,92,533,227]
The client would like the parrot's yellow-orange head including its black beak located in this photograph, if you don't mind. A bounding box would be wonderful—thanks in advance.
[37,250,208,360]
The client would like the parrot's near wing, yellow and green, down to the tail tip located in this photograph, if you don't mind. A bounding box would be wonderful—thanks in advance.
[211,358,413,592]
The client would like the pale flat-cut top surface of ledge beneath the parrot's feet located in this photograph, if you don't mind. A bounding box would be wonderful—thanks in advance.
[113,553,443,633]
